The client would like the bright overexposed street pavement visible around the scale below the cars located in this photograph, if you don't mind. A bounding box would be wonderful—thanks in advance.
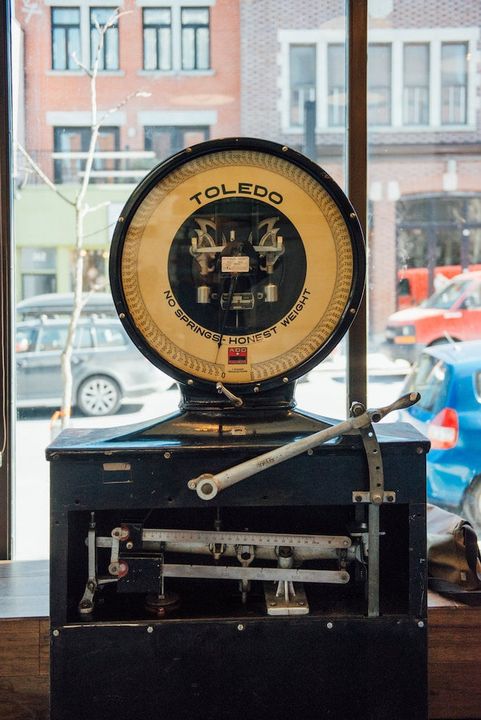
[14,363,403,560]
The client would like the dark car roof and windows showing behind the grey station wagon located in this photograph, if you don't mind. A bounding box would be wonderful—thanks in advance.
[17,292,117,320]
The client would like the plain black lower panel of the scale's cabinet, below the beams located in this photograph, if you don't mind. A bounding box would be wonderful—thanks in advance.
[51,617,427,720]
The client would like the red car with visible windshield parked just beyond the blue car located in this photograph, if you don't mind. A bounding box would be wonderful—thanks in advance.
[384,272,481,362]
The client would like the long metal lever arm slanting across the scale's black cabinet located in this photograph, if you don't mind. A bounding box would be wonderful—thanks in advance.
[188,392,420,500]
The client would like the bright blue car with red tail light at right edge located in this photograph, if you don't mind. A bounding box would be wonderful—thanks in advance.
[401,341,481,530]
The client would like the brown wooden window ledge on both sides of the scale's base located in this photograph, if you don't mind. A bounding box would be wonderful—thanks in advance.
[0,561,481,720]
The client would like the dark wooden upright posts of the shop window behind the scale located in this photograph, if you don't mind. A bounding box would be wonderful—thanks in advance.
[0,0,367,559]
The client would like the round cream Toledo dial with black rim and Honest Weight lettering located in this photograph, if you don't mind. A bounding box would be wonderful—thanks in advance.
[111,140,364,390]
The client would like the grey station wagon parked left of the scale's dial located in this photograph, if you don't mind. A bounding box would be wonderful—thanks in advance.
[16,317,174,415]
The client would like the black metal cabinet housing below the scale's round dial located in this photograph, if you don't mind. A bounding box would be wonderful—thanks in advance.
[47,408,428,720]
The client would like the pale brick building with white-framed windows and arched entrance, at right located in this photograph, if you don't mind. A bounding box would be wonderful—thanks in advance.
[241,0,481,336]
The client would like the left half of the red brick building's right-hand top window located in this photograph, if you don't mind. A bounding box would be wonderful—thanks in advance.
[143,8,172,70]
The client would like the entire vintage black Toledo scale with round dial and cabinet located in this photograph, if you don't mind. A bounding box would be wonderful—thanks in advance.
[47,139,428,720]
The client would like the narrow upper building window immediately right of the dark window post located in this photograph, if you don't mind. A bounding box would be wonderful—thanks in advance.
[367,44,391,125]
